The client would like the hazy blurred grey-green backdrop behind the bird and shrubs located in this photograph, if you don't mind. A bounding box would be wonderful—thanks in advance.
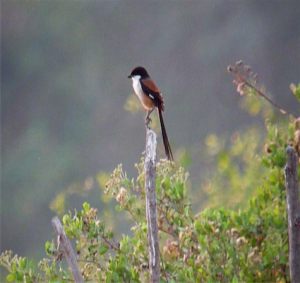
[1,0,300,258]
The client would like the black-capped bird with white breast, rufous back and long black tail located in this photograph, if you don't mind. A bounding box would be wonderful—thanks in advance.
[128,67,173,160]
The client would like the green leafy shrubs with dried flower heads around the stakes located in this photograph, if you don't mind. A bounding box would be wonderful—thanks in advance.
[0,63,300,282]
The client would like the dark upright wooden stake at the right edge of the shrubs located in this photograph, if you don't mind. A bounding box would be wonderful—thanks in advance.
[284,146,300,283]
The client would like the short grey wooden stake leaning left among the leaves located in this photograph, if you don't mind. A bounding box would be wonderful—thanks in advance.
[51,216,83,283]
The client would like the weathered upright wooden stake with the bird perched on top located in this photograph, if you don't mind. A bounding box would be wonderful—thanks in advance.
[144,128,160,283]
